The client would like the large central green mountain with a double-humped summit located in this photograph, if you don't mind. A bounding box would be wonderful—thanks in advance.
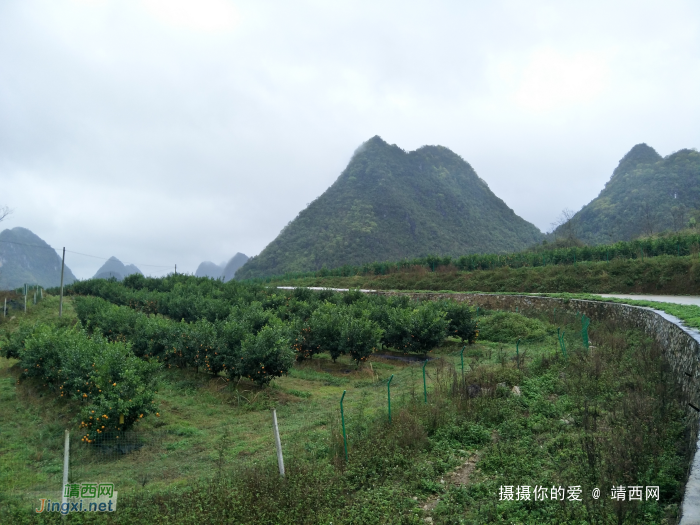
[236,137,543,279]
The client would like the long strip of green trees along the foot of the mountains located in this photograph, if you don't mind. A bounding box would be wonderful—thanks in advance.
[247,233,700,283]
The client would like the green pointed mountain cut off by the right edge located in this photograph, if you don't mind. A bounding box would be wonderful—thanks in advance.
[554,144,700,244]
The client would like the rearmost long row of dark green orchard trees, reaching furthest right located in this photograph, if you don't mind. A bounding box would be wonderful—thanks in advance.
[63,274,476,353]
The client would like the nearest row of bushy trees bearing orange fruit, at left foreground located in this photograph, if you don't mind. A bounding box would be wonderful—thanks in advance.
[3,324,160,443]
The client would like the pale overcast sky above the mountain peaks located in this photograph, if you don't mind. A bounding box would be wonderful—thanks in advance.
[0,0,700,278]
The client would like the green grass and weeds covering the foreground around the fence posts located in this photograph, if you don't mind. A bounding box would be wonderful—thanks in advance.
[0,299,688,524]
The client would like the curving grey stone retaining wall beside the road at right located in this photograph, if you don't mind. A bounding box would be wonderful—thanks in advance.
[375,291,700,525]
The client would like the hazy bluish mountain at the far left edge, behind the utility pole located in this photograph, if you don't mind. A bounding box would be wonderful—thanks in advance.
[0,227,76,290]
